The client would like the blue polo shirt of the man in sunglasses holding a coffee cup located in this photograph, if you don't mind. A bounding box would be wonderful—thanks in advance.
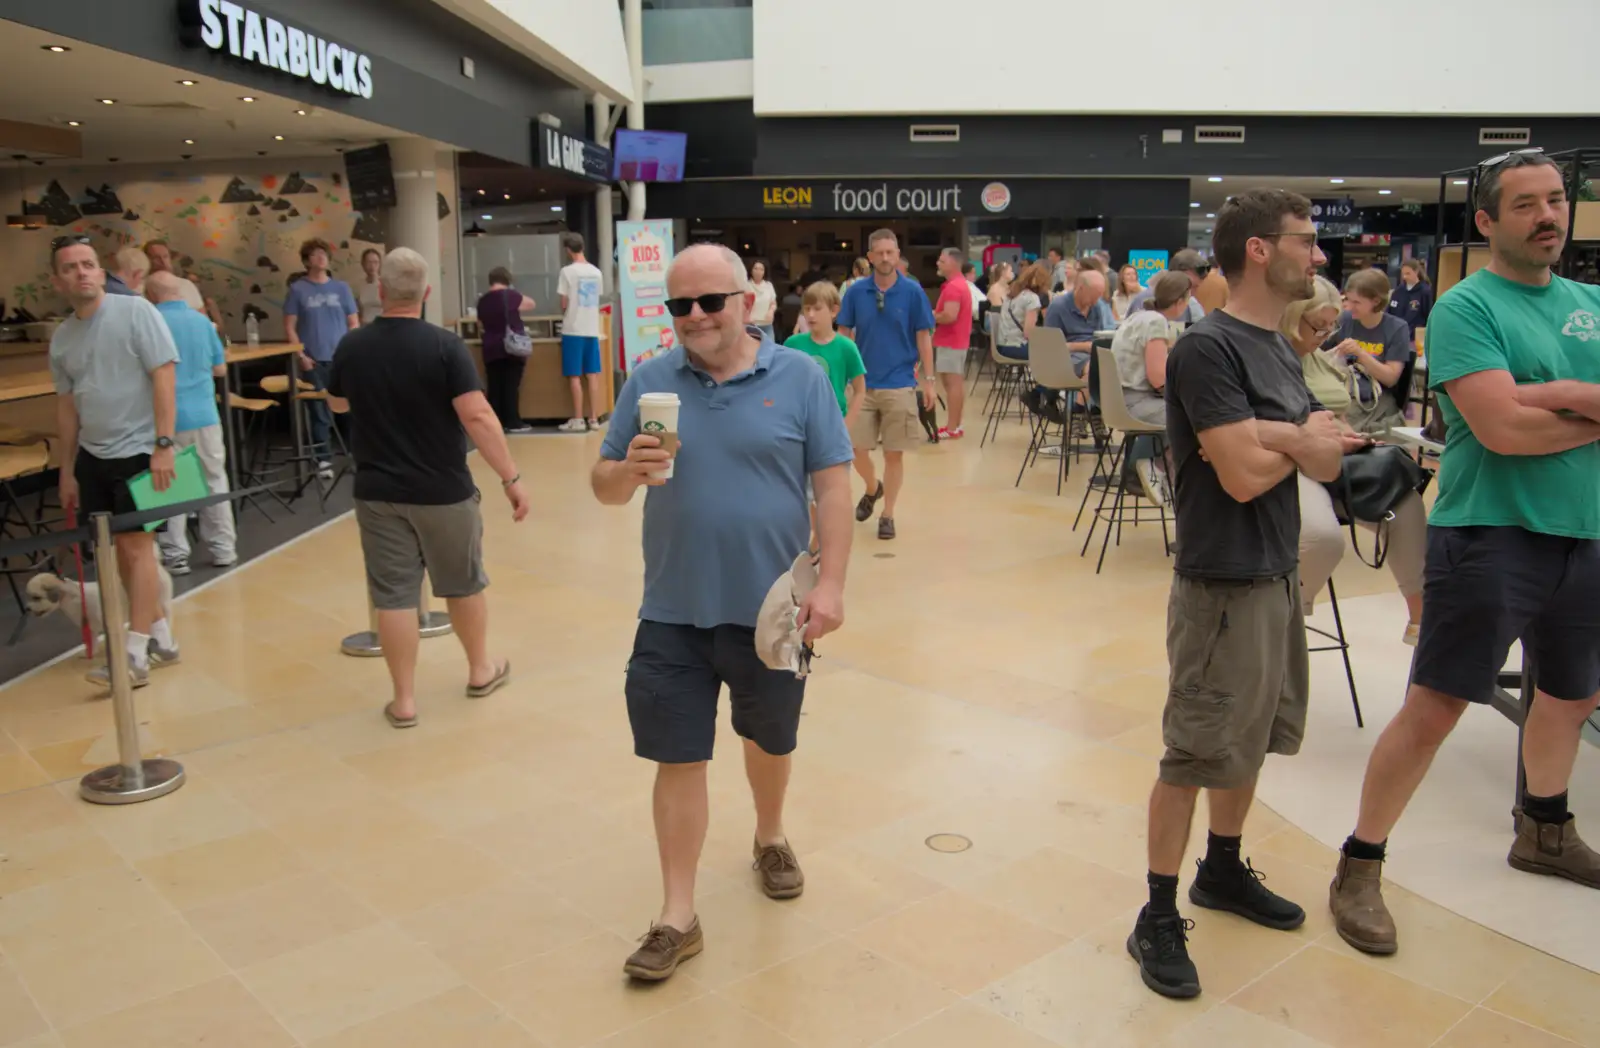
[600,339,856,629]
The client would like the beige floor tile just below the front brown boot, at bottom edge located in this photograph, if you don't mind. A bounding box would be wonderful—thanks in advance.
[1232,946,1472,1048]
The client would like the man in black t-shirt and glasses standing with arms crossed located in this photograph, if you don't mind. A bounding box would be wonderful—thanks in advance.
[1128,189,1344,997]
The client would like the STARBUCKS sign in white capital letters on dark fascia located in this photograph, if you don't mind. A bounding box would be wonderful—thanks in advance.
[178,0,373,98]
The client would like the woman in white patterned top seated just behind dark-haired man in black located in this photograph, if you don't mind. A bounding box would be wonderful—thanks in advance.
[1110,272,1189,506]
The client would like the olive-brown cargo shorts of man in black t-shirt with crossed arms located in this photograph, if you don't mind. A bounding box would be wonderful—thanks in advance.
[1162,573,1310,789]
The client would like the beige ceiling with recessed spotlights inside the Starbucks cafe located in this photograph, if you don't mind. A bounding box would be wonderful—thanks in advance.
[0,20,406,162]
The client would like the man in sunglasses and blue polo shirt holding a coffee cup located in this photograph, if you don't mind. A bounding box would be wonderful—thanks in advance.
[590,245,857,981]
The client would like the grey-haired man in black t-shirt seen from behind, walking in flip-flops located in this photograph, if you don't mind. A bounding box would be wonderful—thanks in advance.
[328,248,528,728]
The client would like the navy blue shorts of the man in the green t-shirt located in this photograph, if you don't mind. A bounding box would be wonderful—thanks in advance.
[1411,526,1600,702]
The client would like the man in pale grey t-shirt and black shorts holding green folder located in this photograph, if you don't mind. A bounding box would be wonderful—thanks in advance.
[50,237,178,688]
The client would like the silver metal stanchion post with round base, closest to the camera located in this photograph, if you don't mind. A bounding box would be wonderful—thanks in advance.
[78,514,184,805]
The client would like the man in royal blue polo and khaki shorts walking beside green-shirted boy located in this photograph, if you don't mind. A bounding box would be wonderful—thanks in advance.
[838,229,936,539]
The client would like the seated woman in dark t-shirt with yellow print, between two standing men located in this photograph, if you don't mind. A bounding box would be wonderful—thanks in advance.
[1325,269,1416,437]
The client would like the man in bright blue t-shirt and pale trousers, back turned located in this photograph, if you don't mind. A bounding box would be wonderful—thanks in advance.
[144,272,238,574]
